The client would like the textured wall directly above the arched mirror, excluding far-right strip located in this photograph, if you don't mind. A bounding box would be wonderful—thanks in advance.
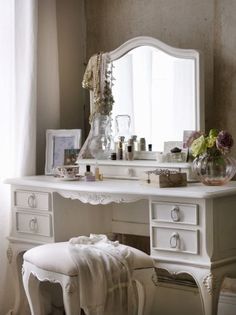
[85,0,214,133]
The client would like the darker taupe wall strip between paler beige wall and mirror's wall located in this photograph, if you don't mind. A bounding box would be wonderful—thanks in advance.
[56,0,85,129]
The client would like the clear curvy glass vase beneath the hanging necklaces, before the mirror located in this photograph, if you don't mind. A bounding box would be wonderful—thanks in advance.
[88,114,113,160]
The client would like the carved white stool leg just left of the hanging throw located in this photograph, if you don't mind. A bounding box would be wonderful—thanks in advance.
[61,276,81,315]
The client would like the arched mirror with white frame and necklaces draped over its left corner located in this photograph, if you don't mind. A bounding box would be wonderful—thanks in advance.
[80,36,204,167]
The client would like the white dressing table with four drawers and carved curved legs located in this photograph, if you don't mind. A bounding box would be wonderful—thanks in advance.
[4,176,236,315]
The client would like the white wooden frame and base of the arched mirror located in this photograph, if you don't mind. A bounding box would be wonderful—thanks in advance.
[80,36,205,177]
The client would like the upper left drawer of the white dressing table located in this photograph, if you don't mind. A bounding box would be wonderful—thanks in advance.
[14,190,50,210]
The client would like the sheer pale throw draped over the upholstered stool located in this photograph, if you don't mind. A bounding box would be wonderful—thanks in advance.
[69,234,136,315]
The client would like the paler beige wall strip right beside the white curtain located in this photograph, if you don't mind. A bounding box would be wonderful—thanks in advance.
[37,0,60,174]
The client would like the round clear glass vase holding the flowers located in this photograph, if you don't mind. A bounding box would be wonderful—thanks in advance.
[193,152,236,186]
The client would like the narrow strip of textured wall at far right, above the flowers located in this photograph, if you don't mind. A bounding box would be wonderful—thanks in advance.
[213,0,236,157]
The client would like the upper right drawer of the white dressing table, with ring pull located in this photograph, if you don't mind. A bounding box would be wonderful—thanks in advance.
[151,202,198,225]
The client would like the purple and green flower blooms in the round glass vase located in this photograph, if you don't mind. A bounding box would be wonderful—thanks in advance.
[187,129,234,157]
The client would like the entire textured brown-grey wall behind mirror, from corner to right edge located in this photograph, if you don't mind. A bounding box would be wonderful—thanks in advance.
[85,0,236,156]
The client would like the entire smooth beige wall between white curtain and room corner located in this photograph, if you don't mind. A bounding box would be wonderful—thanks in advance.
[37,0,86,174]
